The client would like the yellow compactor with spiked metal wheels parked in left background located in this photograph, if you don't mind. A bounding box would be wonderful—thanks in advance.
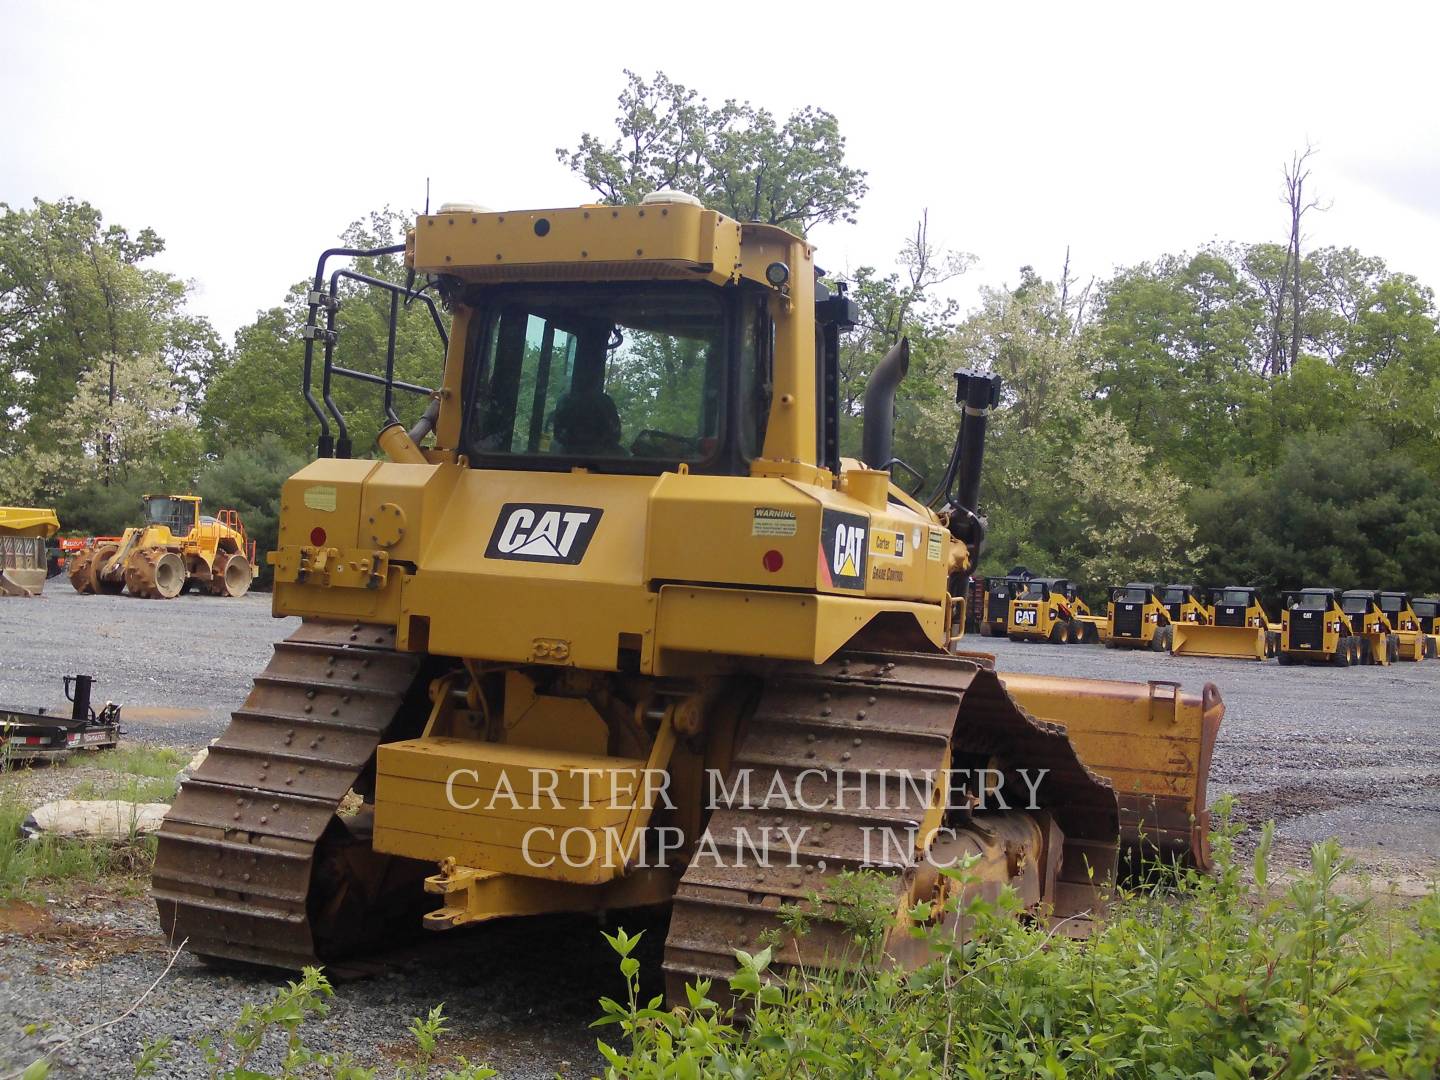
[66,495,255,600]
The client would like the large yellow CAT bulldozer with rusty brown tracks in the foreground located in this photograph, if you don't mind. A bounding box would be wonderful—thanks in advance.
[153,193,1224,999]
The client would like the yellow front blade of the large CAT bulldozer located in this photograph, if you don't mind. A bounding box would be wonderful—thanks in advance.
[1001,672,1225,870]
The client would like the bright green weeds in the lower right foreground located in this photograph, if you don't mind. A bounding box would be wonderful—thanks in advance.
[598,808,1440,1080]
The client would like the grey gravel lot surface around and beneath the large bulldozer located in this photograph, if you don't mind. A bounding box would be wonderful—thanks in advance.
[0,580,1440,1077]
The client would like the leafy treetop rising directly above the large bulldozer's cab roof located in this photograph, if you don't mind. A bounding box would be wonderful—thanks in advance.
[556,71,865,235]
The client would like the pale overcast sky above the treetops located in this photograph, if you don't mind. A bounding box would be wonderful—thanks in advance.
[0,0,1440,337]
